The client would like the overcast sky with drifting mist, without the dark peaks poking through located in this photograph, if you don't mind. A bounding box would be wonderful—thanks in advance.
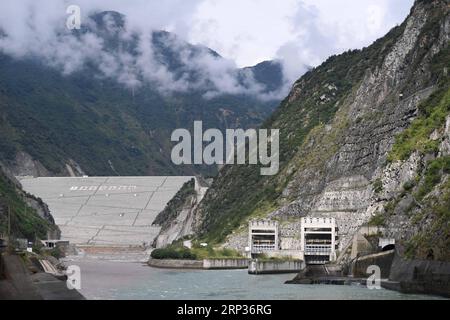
[0,0,413,95]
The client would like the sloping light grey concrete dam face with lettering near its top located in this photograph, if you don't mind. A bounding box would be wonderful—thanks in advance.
[20,176,193,246]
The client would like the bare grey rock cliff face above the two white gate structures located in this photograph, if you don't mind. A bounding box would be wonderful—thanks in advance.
[192,1,450,251]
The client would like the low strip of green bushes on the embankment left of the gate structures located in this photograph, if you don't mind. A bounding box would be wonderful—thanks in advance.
[151,242,243,260]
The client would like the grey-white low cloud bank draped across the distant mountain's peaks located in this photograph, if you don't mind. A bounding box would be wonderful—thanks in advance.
[0,0,284,99]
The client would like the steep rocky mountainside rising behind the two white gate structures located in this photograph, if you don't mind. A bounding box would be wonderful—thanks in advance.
[159,0,450,261]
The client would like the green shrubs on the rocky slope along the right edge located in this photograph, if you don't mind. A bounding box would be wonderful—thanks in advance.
[364,26,450,261]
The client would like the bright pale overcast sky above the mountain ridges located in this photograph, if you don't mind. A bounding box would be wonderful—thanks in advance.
[0,0,413,66]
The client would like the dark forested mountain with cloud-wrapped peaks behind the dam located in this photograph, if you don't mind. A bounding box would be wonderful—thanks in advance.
[0,12,285,176]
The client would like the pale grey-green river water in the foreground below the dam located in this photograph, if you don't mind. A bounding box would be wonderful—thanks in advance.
[68,259,439,300]
